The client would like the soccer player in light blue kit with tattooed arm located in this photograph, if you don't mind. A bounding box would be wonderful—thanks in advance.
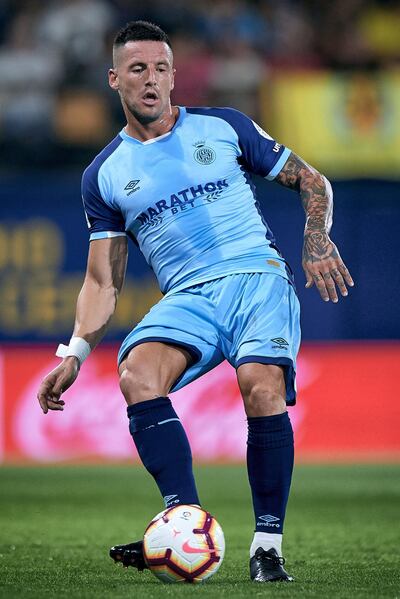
[38,21,353,582]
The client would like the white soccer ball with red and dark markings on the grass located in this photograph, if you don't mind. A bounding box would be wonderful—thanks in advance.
[143,505,225,583]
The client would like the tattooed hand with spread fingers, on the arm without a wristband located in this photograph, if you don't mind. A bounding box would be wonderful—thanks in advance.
[302,229,354,303]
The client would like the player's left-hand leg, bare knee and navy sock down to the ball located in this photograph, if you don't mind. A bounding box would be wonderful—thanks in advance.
[119,342,200,507]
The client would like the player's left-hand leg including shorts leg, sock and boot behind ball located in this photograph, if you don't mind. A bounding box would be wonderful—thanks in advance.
[110,286,224,570]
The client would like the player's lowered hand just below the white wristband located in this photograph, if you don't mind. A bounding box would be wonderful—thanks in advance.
[37,356,79,414]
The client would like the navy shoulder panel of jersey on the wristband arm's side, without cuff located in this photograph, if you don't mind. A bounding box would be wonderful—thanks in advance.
[82,135,125,233]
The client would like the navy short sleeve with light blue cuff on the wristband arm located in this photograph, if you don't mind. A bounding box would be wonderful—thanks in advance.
[82,161,125,241]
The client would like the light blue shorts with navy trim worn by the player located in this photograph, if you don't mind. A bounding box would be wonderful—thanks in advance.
[118,272,300,405]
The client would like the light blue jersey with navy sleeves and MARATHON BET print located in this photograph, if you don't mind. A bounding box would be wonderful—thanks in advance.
[82,107,290,293]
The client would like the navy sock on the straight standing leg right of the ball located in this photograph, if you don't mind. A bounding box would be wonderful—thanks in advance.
[247,412,294,534]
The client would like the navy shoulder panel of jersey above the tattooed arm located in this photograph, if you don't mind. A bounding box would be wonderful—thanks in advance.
[186,108,285,177]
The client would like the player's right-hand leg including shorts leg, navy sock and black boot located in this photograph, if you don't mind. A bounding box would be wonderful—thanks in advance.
[222,273,300,582]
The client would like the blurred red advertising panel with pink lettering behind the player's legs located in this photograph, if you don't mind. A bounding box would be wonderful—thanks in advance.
[0,342,400,462]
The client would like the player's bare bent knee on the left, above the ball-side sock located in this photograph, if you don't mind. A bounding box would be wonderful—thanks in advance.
[119,364,164,405]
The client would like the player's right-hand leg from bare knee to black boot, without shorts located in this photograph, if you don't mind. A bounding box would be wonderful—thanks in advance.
[237,363,294,579]
